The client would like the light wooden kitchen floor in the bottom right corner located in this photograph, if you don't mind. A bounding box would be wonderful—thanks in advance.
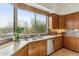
[50,48,79,56]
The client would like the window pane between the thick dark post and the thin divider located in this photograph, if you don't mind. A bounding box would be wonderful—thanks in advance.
[18,9,35,34]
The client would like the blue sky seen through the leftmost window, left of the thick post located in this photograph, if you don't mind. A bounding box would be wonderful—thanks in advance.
[0,3,13,27]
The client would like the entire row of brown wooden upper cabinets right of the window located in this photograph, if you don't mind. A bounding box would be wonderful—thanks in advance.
[51,12,79,30]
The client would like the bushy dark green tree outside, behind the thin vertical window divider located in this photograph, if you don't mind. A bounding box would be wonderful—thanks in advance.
[31,19,46,33]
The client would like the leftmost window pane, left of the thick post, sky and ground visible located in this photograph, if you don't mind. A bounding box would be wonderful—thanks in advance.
[0,3,13,38]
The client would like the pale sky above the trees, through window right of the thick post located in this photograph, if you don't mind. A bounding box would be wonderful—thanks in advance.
[18,9,46,27]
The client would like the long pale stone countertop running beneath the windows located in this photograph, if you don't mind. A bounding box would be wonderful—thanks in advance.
[0,35,61,56]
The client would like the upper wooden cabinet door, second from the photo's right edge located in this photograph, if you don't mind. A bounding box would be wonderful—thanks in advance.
[66,14,74,29]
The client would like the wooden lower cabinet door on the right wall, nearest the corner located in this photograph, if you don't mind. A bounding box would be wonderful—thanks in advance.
[64,36,76,50]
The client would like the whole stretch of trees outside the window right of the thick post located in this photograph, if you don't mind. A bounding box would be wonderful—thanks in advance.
[20,19,46,34]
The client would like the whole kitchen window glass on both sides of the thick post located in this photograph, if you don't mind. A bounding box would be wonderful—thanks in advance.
[0,3,48,40]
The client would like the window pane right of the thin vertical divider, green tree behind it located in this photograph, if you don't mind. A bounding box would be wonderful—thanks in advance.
[36,14,47,33]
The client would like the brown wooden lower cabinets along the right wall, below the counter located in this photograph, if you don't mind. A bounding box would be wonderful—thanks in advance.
[64,36,79,52]
